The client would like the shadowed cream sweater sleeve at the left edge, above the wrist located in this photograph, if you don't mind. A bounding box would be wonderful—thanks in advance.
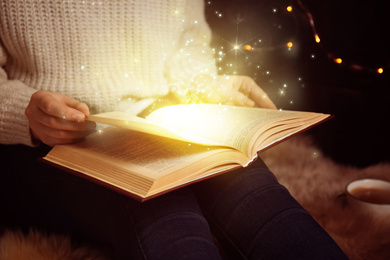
[0,43,36,146]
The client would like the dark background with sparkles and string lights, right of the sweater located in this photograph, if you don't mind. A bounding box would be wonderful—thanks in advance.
[206,0,390,167]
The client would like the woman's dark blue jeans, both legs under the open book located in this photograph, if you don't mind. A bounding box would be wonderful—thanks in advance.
[0,145,346,259]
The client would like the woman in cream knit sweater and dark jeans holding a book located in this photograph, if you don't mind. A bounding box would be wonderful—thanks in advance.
[0,0,344,259]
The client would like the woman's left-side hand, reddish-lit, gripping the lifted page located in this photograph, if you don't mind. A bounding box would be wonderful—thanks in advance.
[25,91,96,146]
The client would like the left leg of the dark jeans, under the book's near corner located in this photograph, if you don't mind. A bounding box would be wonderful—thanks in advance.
[0,146,218,259]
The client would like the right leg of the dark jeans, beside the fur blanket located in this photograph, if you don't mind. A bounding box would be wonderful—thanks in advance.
[193,159,345,259]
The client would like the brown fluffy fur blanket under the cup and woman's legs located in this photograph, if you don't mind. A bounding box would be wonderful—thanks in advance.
[0,137,390,260]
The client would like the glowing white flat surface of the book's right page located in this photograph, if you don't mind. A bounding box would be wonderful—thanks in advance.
[147,104,320,153]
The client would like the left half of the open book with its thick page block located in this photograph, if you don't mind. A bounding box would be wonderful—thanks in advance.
[44,127,248,197]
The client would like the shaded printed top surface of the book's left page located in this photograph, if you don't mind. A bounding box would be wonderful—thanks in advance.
[48,127,232,180]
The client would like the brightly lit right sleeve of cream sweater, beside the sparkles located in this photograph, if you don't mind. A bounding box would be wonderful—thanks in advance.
[165,0,217,97]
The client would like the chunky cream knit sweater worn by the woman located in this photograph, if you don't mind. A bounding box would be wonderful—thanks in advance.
[0,0,216,145]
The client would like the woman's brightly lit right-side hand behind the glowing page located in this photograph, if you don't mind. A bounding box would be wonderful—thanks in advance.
[187,75,276,109]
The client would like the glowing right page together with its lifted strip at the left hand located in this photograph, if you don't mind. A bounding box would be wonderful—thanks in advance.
[88,104,328,155]
